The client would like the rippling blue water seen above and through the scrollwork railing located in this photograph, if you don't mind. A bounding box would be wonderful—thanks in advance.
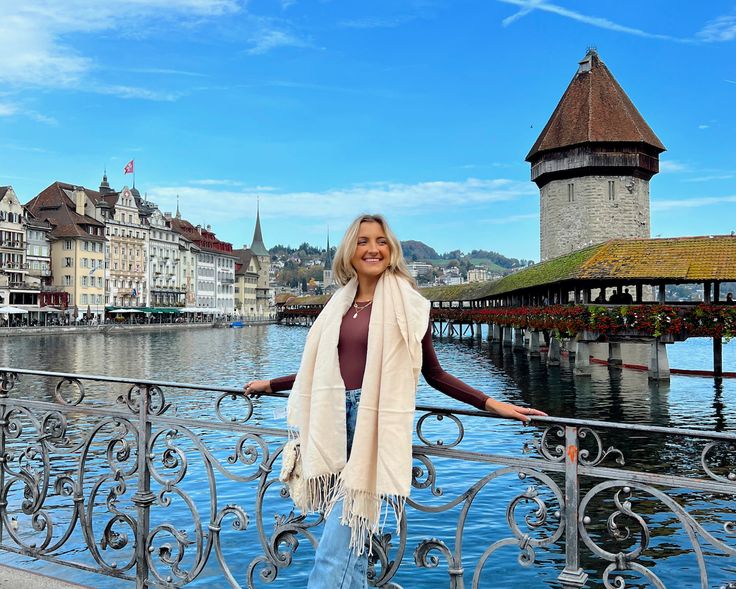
[0,326,736,588]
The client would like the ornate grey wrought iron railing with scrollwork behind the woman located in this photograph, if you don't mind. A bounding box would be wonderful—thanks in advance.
[0,368,736,589]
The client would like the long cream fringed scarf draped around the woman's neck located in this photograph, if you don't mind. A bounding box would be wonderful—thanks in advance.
[287,271,430,553]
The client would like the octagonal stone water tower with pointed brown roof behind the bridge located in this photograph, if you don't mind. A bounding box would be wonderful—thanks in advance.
[526,49,665,261]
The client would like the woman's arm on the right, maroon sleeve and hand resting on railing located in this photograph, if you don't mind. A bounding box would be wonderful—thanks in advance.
[422,325,546,422]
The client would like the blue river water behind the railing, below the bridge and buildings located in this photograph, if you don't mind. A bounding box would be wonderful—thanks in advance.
[0,325,736,588]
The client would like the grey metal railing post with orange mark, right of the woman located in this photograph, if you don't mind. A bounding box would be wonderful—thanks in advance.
[557,425,588,589]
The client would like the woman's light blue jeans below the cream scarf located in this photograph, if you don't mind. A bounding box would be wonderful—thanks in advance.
[307,389,368,589]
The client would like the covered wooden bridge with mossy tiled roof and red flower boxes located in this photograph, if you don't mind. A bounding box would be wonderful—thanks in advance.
[280,235,736,379]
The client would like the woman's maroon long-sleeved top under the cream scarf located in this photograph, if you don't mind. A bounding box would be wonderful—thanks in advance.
[271,307,488,409]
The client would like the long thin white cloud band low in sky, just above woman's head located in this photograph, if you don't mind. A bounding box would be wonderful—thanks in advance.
[148,178,538,224]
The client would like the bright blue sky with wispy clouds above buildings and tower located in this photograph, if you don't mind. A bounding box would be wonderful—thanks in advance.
[0,0,736,260]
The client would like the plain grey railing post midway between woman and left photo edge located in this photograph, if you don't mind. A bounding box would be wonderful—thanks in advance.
[132,385,156,589]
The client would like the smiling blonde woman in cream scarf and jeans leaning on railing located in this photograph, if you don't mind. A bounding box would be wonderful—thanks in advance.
[244,215,545,589]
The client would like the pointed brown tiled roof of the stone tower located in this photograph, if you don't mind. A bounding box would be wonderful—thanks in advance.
[526,49,665,161]
